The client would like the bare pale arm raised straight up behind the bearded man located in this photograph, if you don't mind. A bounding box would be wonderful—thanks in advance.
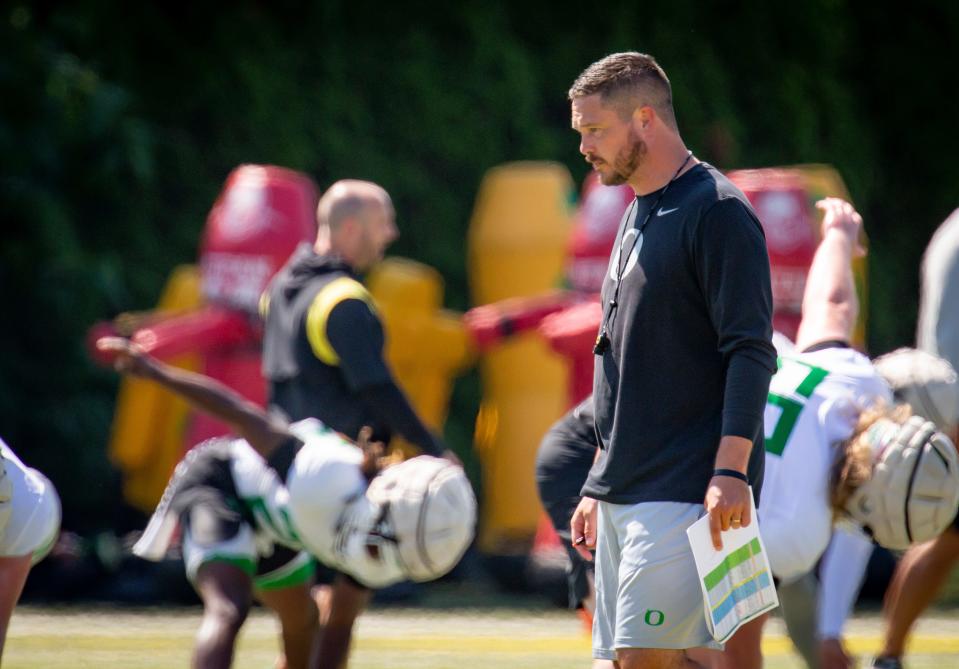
[796,197,865,351]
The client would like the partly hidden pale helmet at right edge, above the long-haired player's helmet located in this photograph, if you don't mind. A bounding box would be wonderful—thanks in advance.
[873,348,959,433]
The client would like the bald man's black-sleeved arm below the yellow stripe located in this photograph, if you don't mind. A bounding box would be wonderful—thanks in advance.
[325,299,446,456]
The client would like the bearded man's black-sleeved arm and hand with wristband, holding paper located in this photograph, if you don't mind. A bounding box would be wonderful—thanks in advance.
[692,198,776,548]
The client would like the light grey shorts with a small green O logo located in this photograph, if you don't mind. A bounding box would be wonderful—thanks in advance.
[593,502,722,660]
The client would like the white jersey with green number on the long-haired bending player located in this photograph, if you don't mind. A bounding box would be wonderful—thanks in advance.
[759,348,892,581]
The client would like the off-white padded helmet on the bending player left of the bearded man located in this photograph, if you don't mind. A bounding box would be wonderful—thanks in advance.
[366,455,476,581]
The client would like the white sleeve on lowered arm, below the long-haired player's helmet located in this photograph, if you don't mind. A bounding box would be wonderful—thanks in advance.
[817,524,873,639]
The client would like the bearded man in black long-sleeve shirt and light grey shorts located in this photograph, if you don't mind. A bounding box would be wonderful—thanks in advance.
[569,53,776,669]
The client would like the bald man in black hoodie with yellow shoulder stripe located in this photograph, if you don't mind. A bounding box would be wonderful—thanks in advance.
[261,180,445,667]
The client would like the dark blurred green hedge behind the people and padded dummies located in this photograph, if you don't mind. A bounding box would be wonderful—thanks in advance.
[0,0,959,530]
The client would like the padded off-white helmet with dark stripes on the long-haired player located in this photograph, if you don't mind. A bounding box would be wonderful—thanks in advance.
[845,416,959,550]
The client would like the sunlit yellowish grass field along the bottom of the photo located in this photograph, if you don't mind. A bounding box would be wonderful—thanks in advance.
[3,606,959,669]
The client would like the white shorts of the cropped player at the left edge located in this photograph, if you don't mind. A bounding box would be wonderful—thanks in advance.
[0,441,60,564]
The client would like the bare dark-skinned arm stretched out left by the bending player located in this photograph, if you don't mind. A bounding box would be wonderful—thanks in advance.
[97,337,290,458]
